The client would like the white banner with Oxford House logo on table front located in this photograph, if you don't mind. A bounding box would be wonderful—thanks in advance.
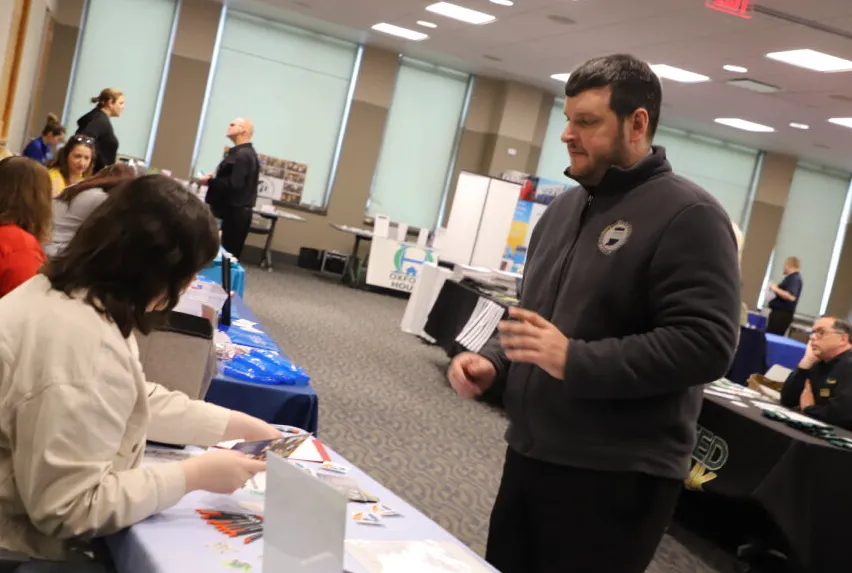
[367,237,438,293]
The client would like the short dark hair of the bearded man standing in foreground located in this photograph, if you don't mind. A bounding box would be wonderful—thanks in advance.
[565,54,663,140]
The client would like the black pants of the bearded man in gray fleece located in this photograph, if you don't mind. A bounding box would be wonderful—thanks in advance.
[485,448,682,573]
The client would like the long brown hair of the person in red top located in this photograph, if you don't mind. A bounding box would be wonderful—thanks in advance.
[0,157,53,243]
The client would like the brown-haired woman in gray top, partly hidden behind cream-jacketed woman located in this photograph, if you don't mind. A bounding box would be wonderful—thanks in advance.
[44,163,136,257]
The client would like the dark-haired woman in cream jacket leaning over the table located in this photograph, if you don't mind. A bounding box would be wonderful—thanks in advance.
[0,175,281,573]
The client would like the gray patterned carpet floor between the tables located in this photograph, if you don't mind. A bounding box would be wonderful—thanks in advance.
[240,263,737,573]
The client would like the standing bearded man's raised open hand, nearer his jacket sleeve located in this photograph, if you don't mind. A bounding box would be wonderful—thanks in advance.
[497,307,568,380]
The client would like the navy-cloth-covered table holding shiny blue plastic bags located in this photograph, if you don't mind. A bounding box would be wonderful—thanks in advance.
[204,295,319,434]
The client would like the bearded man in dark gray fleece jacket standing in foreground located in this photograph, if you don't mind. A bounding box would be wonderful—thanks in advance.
[448,55,740,573]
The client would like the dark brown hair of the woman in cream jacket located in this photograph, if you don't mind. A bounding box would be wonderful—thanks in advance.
[42,175,219,338]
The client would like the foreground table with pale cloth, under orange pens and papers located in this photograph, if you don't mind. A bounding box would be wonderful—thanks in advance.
[106,447,495,573]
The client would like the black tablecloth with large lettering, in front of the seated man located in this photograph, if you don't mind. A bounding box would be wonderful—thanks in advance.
[690,395,852,573]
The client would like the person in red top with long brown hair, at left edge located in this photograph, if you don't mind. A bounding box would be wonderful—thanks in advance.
[0,157,53,297]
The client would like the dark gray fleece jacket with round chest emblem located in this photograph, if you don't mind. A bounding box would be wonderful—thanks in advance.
[482,147,740,479]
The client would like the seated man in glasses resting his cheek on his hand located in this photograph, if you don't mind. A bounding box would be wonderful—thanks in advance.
[781,316,852,430]
